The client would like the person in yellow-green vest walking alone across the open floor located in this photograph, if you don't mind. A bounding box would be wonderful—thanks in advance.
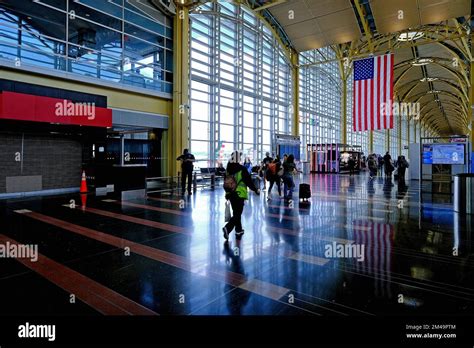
[222,151,260,241]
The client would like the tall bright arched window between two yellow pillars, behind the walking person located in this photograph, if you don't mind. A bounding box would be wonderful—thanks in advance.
[189,2,292,166]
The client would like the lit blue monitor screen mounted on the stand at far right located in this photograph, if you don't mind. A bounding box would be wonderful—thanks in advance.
[423,143,466,165]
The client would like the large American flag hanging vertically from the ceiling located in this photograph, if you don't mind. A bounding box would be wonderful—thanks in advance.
[352,54,393,132]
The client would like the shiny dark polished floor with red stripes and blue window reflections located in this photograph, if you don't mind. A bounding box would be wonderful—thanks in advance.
[0,173,474,316]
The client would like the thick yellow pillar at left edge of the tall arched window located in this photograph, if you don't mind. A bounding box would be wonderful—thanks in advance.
[168,4,190,176]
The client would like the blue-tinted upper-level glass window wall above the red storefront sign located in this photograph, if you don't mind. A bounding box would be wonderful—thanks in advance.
[0,0,173,93]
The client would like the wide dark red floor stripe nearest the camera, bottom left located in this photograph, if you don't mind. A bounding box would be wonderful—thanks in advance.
[0,234,157,315]
